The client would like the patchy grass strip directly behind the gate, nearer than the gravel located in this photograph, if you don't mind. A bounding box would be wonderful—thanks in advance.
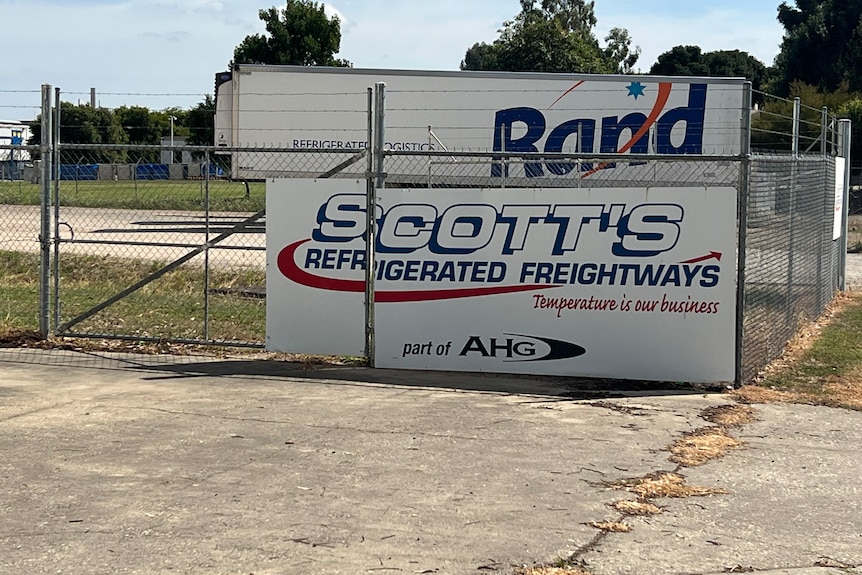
[0,251,266,343]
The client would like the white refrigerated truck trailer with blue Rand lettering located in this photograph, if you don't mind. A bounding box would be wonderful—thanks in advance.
[215,64,748,185]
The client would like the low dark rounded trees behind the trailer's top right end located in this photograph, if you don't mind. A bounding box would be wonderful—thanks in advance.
[650,46,769,90]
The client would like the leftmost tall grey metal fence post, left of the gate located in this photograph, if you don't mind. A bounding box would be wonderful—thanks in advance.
[39,84,53,338]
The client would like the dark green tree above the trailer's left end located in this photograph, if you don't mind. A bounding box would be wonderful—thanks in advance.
[230,0,350,68]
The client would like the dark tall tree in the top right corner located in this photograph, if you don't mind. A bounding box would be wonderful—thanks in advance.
[774,0,862,96]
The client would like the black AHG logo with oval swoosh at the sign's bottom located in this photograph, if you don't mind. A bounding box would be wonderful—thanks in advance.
[458,333,587,362]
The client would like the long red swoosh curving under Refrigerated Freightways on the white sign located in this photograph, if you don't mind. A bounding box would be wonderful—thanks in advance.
[278,239,560,303]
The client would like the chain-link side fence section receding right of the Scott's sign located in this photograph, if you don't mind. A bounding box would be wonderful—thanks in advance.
[742,155,843,381]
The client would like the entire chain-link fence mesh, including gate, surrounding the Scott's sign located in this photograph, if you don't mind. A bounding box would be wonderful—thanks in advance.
[0,83,860,381]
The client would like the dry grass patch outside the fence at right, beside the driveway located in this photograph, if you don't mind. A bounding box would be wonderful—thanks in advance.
[737,294,862,411]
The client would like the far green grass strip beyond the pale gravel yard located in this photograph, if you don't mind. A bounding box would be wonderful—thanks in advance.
[0,180,266,212]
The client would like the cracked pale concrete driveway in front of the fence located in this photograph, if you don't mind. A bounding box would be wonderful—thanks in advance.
[0,349,862,575]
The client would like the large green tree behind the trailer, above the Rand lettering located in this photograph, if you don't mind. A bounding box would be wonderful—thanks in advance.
[461,0,640,74]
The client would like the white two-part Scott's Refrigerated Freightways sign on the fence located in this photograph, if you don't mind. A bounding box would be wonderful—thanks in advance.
[267,181,736,382]
